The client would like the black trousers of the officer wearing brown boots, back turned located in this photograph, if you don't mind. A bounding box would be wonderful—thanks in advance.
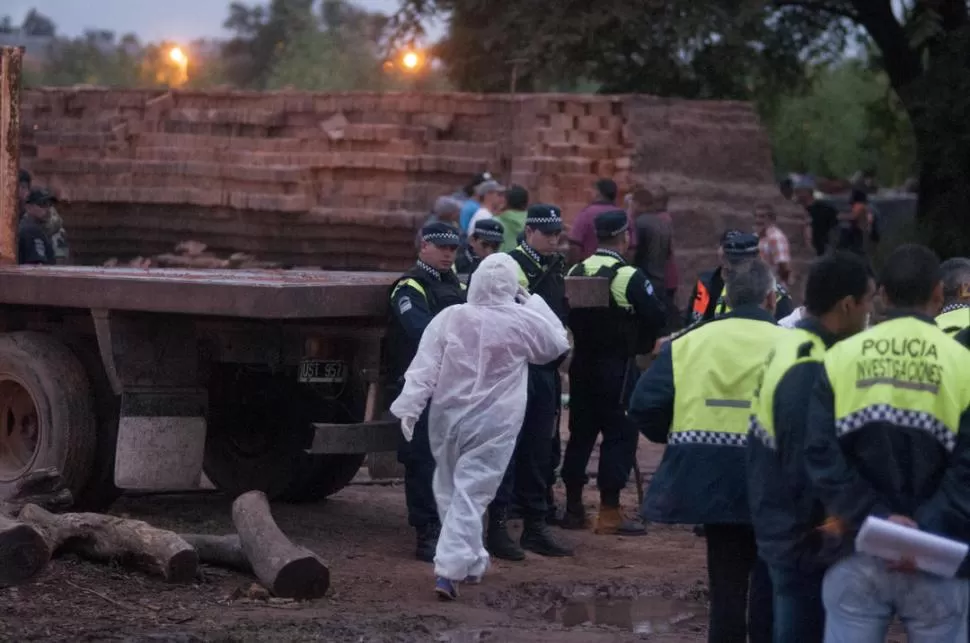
[562,355,638,494]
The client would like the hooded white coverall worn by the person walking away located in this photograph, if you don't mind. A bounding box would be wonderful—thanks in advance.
[391,254,569,581]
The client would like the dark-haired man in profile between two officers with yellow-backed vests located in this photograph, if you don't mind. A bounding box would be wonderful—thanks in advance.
[747,253,876,643]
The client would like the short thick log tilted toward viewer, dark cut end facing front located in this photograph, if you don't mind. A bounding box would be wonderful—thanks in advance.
[232,491,330,599]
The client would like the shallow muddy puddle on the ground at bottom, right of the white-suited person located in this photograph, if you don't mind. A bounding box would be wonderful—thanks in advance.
[545,596,704,634]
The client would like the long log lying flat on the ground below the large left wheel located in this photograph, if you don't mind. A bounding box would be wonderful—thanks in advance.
[20,505,199,583]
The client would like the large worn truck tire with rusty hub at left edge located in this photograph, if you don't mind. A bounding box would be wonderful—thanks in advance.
[0,332,97,498]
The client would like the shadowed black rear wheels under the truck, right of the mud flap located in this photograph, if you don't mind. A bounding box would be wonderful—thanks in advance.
[204,365,364,502]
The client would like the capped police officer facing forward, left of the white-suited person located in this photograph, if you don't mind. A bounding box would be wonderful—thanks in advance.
[385,222,465,562]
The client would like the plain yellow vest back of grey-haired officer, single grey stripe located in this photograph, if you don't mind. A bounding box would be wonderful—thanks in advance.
[667,318,789,446]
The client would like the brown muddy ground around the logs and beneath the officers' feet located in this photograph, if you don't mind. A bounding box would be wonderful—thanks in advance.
[0,444,720,643]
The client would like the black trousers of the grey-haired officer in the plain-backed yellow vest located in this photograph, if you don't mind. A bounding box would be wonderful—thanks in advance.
[704,525,773,643]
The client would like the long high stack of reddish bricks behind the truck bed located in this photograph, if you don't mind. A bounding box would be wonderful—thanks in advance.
[21,88,800,286]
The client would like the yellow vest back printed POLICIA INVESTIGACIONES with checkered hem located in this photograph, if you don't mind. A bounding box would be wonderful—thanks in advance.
[825,317,970,451]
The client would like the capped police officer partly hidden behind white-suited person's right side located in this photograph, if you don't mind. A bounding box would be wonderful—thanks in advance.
[485,204,572,560]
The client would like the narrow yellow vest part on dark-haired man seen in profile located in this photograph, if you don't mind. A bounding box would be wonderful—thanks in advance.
[748,328,825,449]
